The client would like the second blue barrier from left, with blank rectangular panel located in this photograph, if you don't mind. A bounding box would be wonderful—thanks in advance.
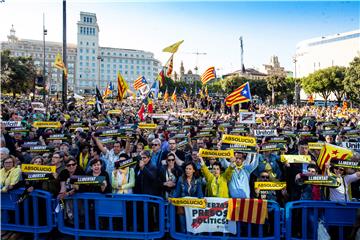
[58,193,165,239]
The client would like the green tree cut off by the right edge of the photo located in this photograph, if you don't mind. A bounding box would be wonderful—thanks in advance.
[344,57,360,103]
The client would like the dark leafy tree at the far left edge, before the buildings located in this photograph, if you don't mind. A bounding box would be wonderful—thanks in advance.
[1,50,36,97]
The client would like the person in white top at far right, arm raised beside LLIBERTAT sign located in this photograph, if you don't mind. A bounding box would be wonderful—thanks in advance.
[325,164,360,202]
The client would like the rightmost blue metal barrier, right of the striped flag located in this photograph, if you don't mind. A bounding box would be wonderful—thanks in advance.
[285,201,360,240]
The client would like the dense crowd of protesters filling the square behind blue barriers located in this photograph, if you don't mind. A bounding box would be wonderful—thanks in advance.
[0,95,360,238]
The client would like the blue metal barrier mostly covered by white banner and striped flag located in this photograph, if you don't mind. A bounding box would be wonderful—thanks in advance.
[169,201,283,240]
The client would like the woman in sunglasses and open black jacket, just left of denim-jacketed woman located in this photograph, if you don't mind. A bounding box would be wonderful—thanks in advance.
[159,153,183,199]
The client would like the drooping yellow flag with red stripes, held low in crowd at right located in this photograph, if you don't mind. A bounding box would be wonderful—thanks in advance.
[317,143,353,172]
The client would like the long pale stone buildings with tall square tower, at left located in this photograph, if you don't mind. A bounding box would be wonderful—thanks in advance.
[1,12,161,94]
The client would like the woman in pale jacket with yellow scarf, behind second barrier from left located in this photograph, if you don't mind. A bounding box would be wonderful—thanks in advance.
[111,153,135,194]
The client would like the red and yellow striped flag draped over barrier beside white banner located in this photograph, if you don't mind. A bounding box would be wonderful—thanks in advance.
[226,198,268,224]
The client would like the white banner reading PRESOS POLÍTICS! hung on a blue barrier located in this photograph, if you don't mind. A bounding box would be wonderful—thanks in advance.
[185,198,236,234]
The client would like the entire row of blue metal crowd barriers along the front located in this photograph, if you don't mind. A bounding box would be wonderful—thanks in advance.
[1,189,360,240]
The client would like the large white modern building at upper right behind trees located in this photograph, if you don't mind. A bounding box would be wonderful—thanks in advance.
[294,29,360,78]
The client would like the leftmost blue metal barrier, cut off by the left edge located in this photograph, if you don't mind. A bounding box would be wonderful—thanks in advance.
[1,188,55,239]
